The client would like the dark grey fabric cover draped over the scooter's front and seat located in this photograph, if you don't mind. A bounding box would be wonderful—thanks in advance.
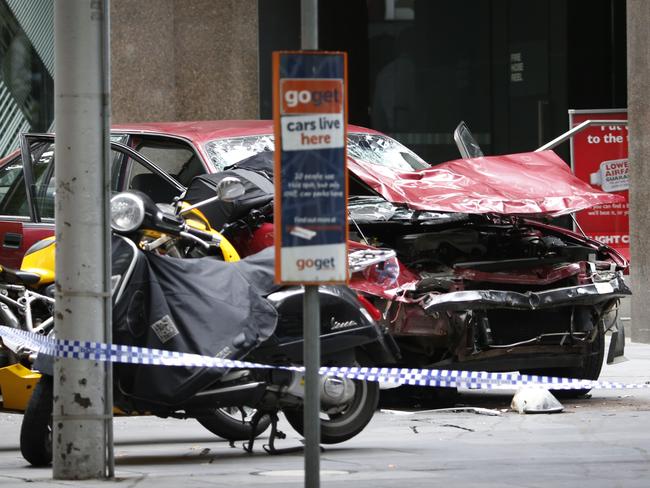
[113,238,277,406]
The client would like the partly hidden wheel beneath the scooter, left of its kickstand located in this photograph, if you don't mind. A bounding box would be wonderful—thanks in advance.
[196,407,271,441]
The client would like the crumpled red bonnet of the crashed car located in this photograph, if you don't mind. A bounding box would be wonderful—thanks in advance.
[348,151,623,217]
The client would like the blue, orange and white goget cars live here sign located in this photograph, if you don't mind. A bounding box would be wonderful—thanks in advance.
[273,51,348,284]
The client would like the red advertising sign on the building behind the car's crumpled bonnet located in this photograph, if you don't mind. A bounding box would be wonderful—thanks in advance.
[569,109,630,259]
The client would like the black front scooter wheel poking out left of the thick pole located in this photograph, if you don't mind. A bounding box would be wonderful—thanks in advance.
[20,375,53,466]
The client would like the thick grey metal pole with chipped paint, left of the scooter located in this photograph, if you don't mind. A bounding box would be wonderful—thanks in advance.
[52,0,113,479]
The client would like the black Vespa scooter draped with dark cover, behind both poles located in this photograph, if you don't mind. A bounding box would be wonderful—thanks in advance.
[21,192,396,465]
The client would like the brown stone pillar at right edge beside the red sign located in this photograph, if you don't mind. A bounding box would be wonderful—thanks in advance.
[627,0,650,343]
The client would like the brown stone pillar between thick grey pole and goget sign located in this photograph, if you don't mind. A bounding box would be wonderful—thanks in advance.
[111,0,259,123]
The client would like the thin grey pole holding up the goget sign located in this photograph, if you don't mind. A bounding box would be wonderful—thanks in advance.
[300,0,320,488]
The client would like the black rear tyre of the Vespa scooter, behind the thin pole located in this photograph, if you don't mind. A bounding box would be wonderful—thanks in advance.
[283,381,379,444]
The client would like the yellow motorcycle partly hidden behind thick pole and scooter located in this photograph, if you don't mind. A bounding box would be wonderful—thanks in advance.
[0,178,243,411]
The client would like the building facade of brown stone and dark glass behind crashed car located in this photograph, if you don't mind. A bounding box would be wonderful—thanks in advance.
[0,0,627,163]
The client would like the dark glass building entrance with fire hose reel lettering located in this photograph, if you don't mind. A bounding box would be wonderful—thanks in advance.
[259,0,627,164]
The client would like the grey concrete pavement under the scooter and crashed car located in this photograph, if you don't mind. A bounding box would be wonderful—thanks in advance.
[0,336,650,488]
